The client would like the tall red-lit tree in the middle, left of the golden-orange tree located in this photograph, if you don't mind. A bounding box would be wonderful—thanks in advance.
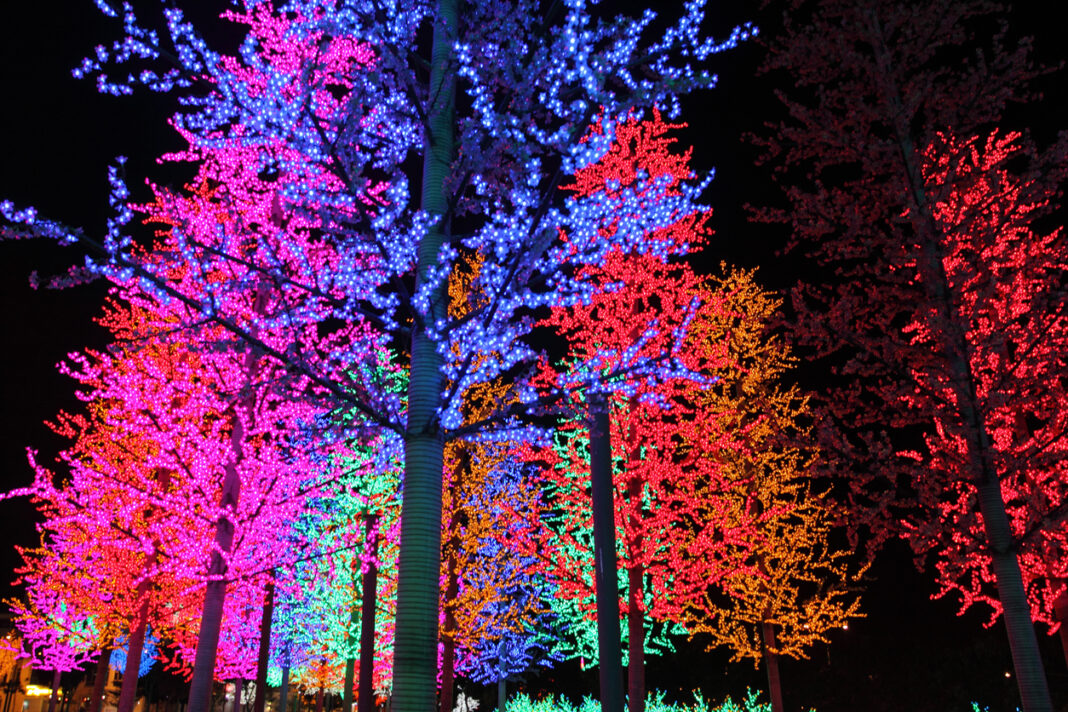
[529,115,756,712]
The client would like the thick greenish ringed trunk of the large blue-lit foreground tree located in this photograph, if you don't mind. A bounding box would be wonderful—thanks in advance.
[393,0,458,712]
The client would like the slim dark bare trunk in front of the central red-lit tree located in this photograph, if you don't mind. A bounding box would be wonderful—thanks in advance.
[590,394,623,712]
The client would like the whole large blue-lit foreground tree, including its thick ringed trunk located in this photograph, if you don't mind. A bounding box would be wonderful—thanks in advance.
[2,0,751,712]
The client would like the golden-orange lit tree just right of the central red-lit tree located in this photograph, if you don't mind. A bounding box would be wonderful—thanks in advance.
[676,270,863,712]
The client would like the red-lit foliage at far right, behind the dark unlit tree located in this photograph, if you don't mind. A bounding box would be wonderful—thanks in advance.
[901,132,1068,630]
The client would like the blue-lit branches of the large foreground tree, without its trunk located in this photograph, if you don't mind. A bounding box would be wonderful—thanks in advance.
[12,0,755,446]
